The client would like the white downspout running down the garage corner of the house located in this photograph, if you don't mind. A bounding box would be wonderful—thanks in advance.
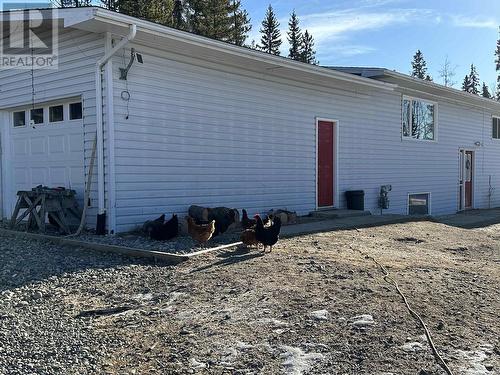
[95,24,137,229]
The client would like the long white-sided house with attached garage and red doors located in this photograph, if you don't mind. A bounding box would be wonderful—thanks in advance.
[0,8,500,232]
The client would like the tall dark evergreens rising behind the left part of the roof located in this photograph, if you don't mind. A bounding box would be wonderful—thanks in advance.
[54,0,318,64]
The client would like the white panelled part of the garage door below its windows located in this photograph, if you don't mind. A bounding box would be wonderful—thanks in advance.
[10,111,85,206]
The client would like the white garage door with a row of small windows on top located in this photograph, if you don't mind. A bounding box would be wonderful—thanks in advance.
[10,101,85,209]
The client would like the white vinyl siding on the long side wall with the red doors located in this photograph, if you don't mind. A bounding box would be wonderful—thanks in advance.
[113,45,500,231]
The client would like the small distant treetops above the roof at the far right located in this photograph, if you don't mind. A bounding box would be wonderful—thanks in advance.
[411,33,500,101]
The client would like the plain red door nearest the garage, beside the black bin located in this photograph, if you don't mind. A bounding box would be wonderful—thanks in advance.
[318,121,335,207]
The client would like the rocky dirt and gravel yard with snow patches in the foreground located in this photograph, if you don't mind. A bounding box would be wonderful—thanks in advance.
[0,222,500,375]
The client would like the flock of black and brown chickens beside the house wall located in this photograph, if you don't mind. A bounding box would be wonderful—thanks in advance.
[143,210,288,252]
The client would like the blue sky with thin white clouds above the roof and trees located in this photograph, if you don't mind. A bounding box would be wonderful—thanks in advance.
[242,0,500,88]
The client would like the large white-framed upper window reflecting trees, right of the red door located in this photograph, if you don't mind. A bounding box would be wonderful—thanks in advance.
[403,97,436,141]
